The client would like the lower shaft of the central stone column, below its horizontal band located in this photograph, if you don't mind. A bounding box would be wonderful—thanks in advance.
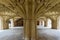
[24,19,37,40]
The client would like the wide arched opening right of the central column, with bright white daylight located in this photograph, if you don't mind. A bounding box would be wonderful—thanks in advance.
[37,17,52,28]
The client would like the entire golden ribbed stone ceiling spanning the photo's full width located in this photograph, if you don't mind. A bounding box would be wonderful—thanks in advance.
[0,0,60,18]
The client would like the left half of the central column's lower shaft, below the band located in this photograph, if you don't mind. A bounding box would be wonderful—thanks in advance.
[23,19,31,40]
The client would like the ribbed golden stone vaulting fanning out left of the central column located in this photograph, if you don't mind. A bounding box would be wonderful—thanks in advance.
[0,0,25,16]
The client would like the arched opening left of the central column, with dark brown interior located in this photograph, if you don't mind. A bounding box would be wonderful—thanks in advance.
[9,17,23,28]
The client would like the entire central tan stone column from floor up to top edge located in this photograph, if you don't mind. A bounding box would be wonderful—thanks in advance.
[24,0,37,40]
